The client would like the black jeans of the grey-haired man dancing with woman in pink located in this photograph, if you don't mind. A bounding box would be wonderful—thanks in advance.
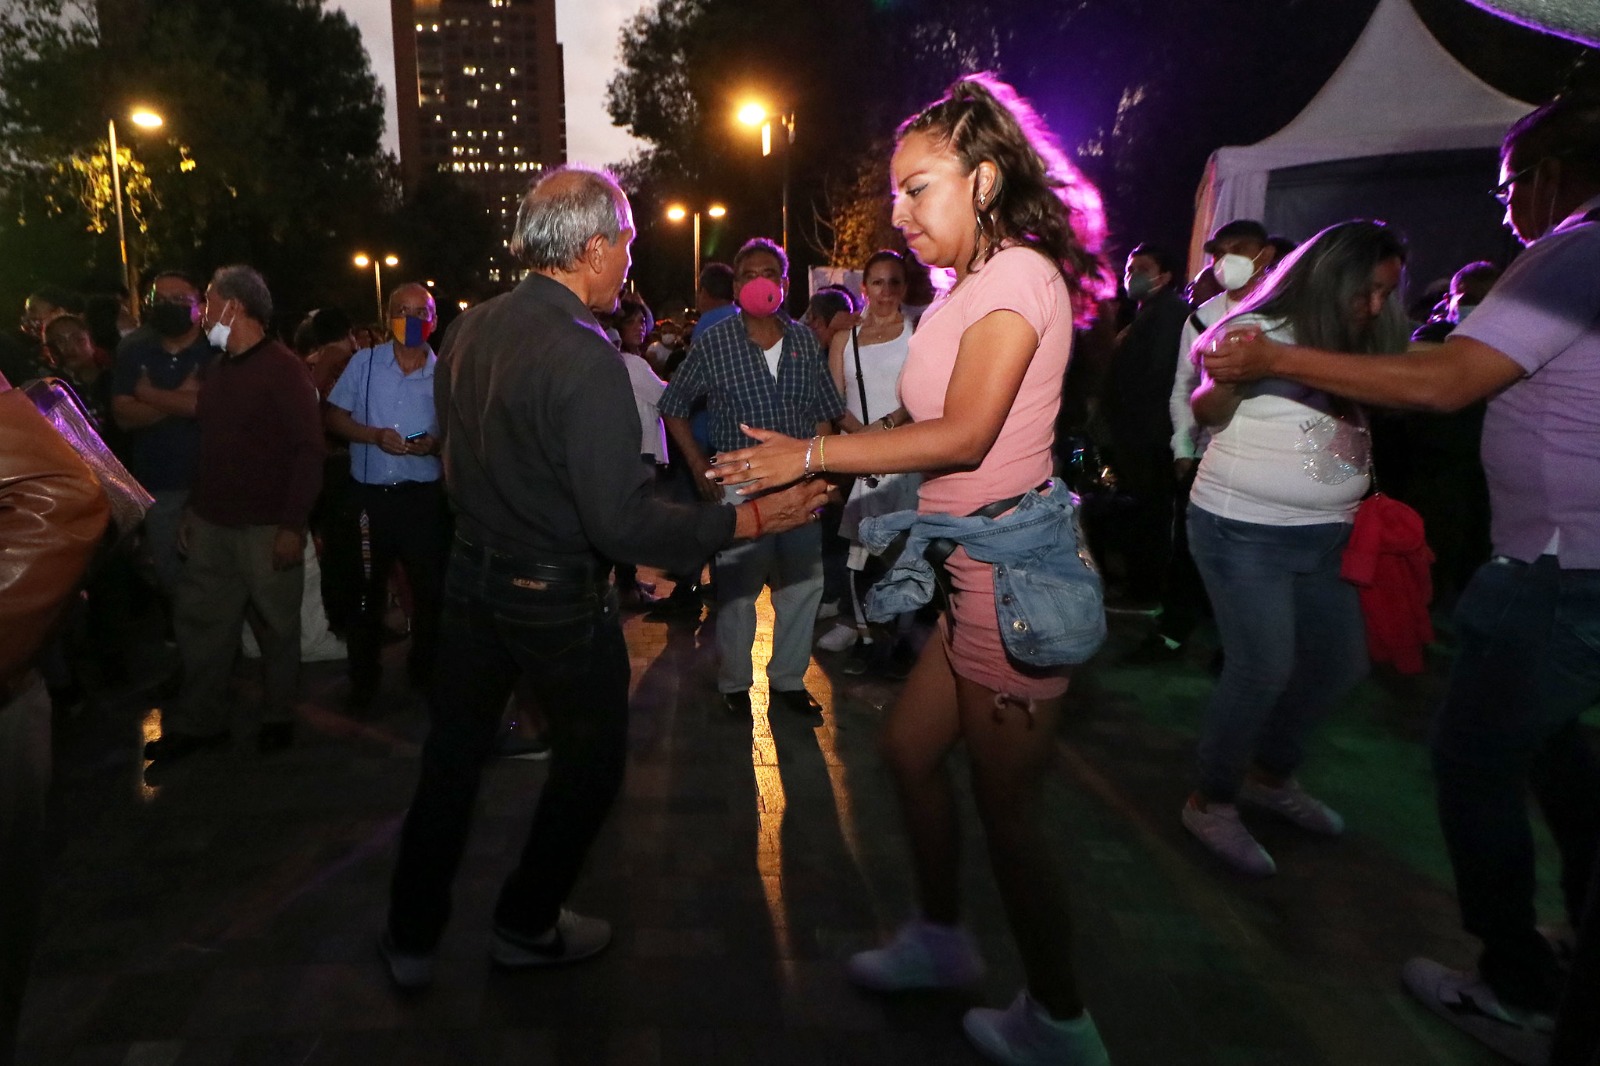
[389,539,629,954]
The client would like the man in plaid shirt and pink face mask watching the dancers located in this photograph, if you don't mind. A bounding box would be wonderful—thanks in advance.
[661,237,845,717]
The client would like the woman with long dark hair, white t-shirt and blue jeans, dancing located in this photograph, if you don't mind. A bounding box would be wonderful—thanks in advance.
[1182,221,1410,876]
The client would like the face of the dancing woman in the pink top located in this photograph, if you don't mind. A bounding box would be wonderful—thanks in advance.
[890,133,978,271]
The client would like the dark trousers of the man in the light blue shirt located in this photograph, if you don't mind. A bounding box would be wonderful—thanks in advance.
[347,482,450,685]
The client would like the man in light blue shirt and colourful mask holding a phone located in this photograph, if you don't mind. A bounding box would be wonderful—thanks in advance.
[323,283,450,711]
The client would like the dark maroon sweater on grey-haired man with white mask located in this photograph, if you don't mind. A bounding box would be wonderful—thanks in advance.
[189,341,323,528]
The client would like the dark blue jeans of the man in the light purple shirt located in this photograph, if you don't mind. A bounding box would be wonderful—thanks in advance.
[1432,555,1600,1008]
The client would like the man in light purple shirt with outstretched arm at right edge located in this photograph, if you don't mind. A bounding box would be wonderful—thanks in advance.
[1205,98,1600,1063]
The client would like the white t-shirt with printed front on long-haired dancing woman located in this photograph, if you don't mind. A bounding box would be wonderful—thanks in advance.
[1189,315,1373,525]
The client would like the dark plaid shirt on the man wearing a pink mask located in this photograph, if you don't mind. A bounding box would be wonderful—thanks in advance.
[661,314,845,451]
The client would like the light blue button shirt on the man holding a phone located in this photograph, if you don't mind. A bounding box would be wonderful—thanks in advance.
[328,341,442,485]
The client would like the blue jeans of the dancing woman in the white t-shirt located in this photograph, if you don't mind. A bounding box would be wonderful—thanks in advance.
[1189,506,1368,804]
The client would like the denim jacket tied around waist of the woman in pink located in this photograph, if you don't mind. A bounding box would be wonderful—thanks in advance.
[861,483,1106,666]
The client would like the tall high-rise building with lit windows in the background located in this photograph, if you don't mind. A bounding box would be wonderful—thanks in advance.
[390,0,566,273]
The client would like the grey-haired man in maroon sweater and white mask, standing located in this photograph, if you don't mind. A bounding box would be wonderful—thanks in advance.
[136,266,323,762]
